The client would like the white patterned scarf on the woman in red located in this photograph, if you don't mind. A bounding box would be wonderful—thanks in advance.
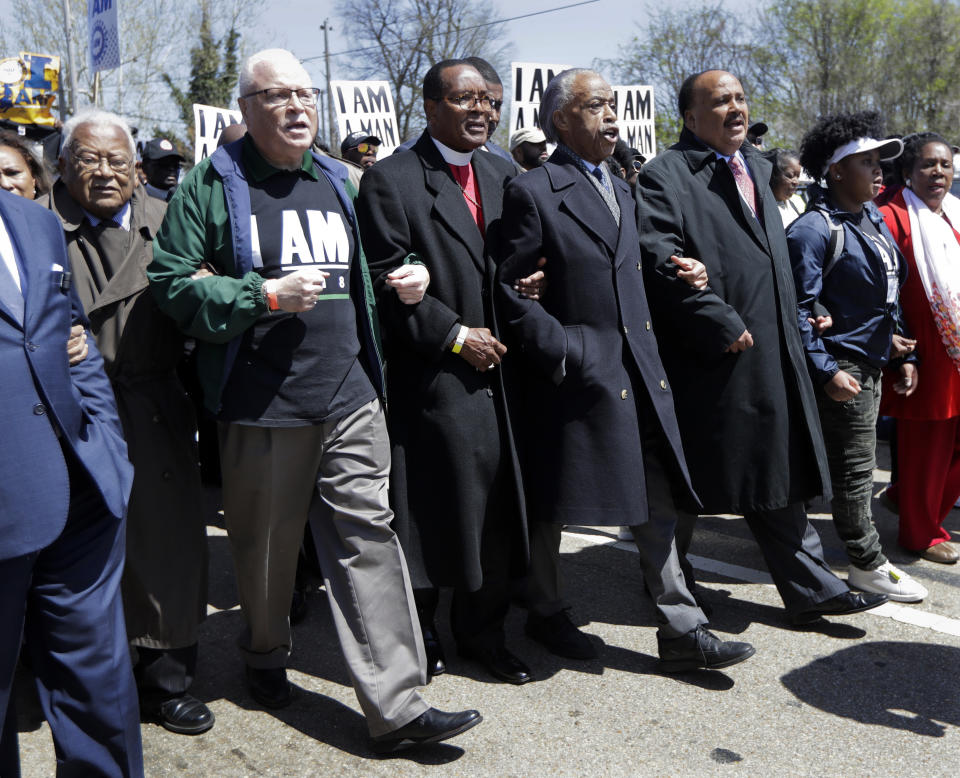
[903,187,960,371]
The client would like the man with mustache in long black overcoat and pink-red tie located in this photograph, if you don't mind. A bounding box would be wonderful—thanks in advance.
[638,70,883,623]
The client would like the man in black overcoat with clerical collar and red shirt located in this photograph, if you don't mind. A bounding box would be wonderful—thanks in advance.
[357,60,531,683]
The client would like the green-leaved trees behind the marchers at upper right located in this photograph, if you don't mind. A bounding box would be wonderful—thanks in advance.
[607,0,960,148]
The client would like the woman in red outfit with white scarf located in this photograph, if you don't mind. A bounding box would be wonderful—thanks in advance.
[880,132,960,564]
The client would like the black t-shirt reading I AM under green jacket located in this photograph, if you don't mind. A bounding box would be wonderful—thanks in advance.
[219,144,376,426]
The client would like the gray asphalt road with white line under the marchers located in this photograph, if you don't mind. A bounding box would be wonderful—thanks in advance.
[20,452,960,778]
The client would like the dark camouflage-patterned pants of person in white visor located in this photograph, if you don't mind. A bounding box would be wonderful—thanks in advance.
[817,358,887,570]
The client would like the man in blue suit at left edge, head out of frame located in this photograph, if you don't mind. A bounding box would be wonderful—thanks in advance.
[0,192,143,776]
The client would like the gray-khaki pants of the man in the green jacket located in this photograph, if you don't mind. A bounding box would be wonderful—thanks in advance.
[219,400,429,736]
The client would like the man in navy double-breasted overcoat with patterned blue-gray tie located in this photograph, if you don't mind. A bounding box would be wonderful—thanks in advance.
[492,69,753,670]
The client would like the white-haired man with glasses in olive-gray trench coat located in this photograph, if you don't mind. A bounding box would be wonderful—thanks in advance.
[47,111,214,734]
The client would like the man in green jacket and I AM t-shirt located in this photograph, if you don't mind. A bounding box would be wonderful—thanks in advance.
[148,49,480,751]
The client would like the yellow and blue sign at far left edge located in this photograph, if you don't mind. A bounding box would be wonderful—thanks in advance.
[0,51,60,127]
